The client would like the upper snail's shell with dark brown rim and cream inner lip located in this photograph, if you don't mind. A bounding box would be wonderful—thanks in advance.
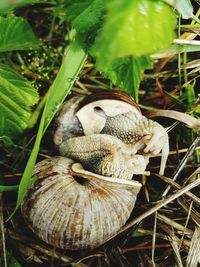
[54,90,141,146]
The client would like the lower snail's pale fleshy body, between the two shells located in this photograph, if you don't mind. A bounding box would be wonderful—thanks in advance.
[60,134,149,179]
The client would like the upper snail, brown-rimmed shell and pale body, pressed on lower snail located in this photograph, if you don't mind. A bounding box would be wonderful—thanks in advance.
[54,90,169,175]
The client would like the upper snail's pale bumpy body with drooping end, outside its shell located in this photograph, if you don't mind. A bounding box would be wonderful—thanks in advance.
[101,111,169,174]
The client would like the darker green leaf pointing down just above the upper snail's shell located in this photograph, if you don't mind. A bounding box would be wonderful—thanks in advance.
[98,56,152,102]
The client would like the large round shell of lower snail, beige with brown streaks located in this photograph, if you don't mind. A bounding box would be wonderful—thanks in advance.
[21,157,141,250]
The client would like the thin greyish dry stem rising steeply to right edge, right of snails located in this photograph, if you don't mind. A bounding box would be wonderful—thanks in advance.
[162,136,200,197]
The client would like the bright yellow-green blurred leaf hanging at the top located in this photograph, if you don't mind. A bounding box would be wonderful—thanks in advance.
[97,0,176,66]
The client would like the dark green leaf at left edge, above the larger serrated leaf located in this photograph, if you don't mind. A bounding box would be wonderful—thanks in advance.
[0,16,37,52]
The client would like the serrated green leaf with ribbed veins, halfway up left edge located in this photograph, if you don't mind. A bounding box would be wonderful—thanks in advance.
[0,64,38,138]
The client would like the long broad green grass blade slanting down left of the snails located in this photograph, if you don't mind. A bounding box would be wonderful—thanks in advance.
[10,39,87,217]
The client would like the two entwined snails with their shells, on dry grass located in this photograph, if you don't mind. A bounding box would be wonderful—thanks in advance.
[22,90,169,250]
